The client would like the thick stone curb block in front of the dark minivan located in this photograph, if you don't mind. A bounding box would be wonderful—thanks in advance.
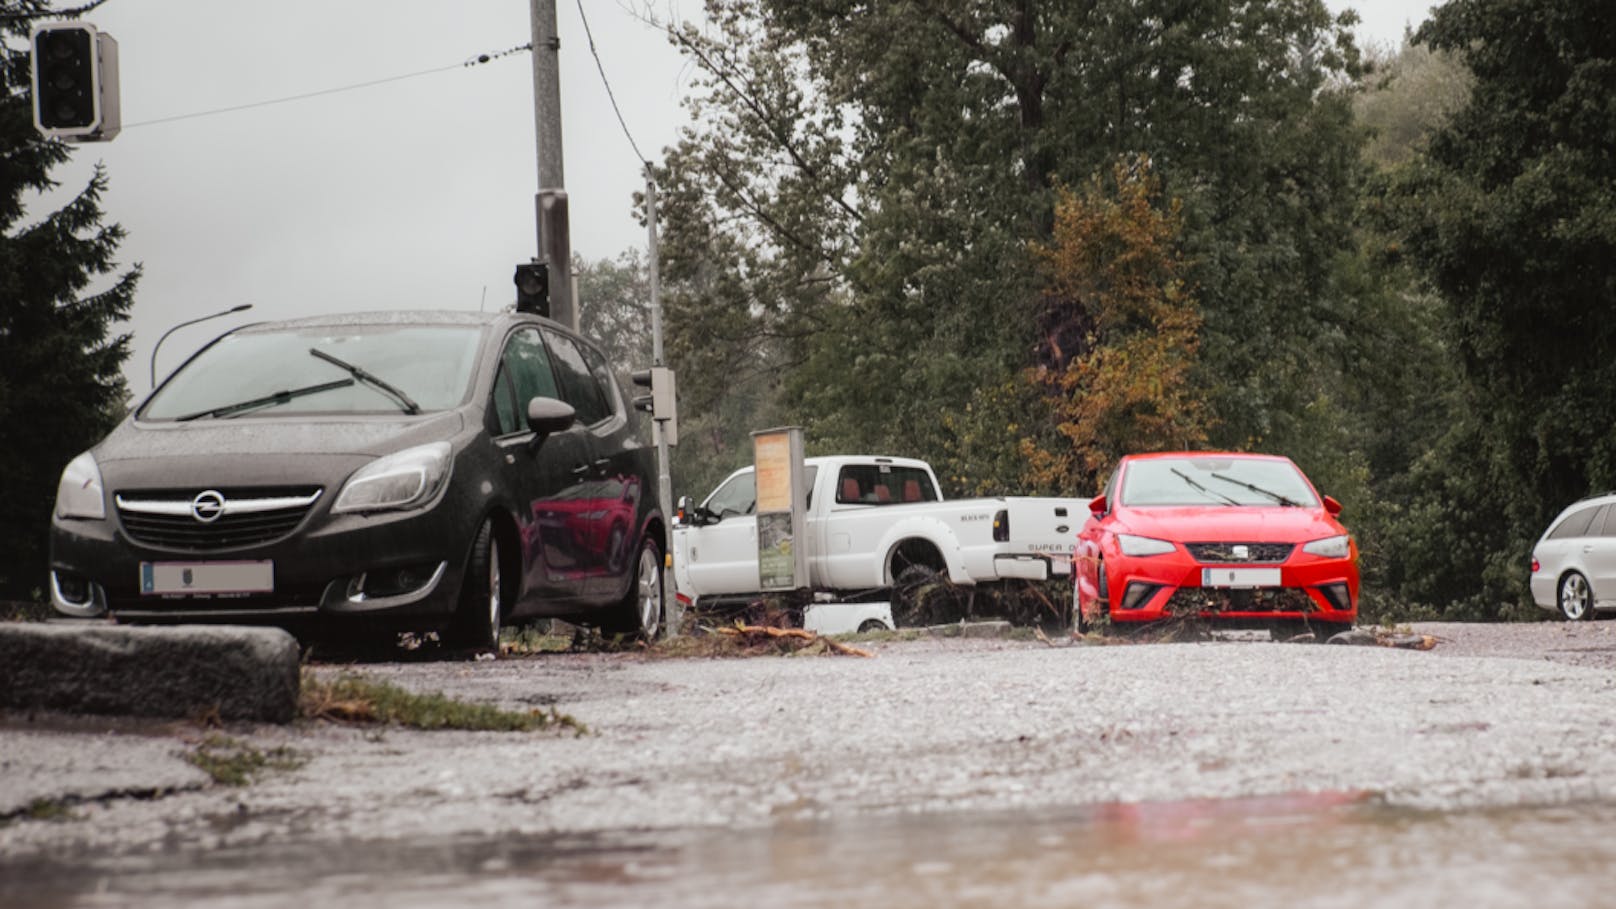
[0,623,299,723]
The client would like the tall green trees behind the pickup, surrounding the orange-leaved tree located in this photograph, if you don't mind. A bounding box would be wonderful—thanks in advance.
[664,0,1362,488]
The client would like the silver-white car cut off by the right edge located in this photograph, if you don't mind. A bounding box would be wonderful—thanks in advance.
[1530,493,1616,621]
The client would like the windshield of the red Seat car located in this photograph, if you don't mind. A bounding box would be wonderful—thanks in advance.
[1122,458,1319,508]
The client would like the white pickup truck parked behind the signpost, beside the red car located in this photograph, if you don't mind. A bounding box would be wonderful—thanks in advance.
[674,456,1088,605]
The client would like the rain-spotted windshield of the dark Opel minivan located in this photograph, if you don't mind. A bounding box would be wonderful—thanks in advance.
[139,325,482,421]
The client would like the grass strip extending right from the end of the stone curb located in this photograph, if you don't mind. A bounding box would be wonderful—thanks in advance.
[301,671,588,736]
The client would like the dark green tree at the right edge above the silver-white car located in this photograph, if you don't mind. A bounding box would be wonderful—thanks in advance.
[1387,0,1616,616]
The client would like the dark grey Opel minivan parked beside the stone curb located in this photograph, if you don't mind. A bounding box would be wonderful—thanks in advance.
[50,312,666,649]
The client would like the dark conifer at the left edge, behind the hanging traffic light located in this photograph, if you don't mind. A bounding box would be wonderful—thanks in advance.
[0,7,141,598]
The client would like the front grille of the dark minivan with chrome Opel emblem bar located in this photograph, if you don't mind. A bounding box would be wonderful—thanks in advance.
[115,487,322,552]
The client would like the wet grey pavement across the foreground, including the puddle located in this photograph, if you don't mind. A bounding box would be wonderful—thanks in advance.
[9,623,1616,909]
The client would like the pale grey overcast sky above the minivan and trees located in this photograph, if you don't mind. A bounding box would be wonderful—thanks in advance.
[28,0,1429,396]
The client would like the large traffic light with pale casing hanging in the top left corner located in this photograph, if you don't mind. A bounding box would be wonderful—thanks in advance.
[29,23,120,141]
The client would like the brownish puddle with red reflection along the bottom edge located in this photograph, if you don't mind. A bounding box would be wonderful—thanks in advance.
[0,793,1616,909]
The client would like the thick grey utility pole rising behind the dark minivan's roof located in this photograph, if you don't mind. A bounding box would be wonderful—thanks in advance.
[530,0,579,330]
